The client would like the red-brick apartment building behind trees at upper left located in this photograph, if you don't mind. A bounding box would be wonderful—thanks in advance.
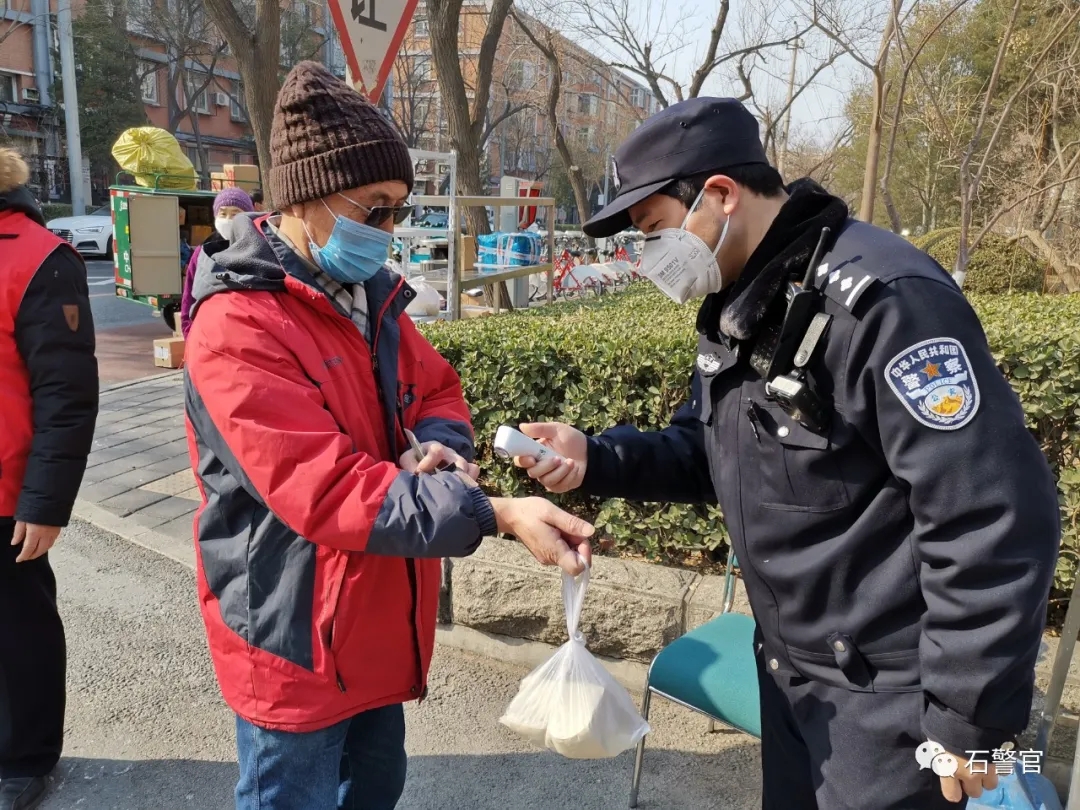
[0,0,345,200]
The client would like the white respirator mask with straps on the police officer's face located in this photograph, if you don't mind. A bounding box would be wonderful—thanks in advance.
[640,189,731,303]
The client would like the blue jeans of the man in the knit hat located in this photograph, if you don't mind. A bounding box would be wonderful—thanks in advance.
[237,704,406,810]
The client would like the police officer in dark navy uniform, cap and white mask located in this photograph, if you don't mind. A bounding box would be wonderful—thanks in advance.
[517,98,1059,810]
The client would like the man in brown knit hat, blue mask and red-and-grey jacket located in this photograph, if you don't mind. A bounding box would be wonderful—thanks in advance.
[186,63,592,810]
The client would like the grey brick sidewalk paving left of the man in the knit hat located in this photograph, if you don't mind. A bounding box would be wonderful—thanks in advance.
[79,372,199,542]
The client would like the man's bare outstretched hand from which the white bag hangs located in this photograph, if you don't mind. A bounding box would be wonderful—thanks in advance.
[491,498,595,577]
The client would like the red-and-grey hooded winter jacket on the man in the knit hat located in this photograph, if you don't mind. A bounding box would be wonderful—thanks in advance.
[185,217,495,731]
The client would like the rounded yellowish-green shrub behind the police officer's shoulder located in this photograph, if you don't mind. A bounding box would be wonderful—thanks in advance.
[914,228,1045,295]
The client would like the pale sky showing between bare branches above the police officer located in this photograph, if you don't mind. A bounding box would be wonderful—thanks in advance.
[552,0,888,144]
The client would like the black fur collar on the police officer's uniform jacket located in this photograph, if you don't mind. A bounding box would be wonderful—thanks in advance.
[698,178,848,340]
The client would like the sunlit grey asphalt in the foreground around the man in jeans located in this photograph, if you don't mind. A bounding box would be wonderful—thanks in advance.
[42,522,760,810]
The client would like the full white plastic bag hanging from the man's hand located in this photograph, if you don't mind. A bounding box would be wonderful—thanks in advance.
[499,568,649,759]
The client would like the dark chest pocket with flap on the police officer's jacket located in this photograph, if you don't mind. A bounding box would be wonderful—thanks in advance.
[744,399,849,512]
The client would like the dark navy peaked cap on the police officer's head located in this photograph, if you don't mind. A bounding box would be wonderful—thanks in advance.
[583,97,769,239]
